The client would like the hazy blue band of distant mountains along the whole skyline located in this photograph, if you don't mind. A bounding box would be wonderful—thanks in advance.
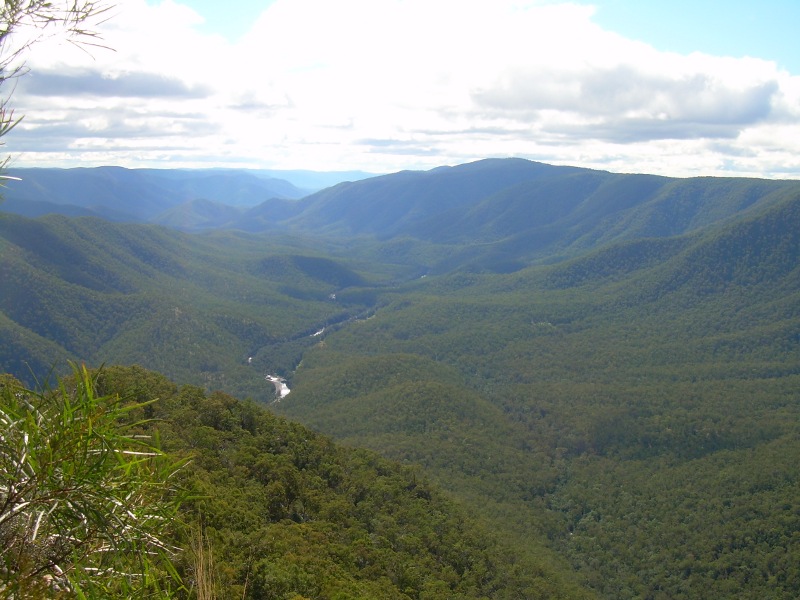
[2,158,800,251]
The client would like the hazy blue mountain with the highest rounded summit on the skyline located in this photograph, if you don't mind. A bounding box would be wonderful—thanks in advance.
[285,159,800,262]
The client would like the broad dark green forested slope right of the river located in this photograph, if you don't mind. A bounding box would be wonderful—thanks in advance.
[276,186,800,598]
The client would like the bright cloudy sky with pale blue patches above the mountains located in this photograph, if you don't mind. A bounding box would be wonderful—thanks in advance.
[0,0,800,179]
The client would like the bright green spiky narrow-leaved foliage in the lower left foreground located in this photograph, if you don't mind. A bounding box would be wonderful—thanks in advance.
[0,367,180,598]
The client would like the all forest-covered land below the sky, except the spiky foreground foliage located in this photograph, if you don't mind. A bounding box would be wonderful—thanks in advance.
[0,159,800,600]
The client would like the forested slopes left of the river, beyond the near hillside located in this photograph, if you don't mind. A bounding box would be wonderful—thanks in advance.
[0,214,394,397]
